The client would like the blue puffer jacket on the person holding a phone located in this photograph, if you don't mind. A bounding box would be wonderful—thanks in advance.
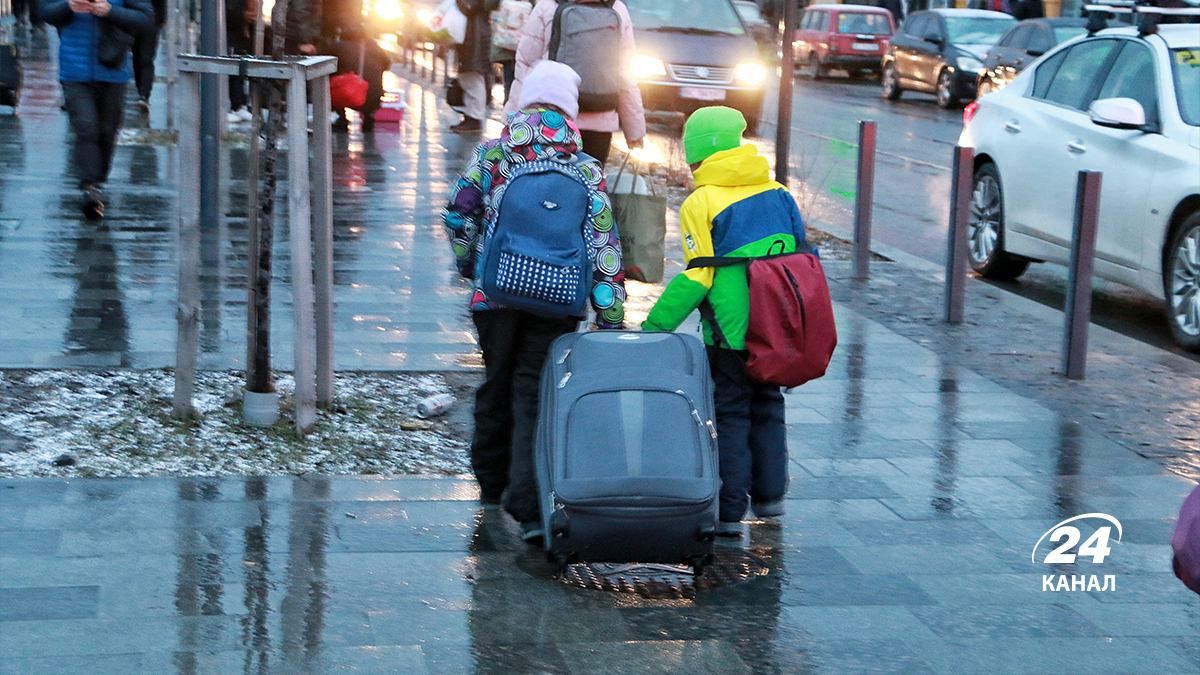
[42,0,155,84]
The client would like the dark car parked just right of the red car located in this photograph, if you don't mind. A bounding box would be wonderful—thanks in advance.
[883,10,1016,108]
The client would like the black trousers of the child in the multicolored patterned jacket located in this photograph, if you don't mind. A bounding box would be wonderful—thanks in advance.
[470,310,578,522]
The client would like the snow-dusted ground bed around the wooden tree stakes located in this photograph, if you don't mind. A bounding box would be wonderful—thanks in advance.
[0,370,470,477]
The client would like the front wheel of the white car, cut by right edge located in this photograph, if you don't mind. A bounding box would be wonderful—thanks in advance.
[1163,211,1200,352]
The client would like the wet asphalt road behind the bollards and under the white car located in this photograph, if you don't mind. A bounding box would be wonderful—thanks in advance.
[760,70,1200,360]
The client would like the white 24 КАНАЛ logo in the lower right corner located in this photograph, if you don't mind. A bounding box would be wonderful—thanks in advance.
[1030,513,1124,591]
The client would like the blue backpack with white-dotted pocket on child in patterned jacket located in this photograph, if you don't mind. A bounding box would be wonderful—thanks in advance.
[480,160,592,317]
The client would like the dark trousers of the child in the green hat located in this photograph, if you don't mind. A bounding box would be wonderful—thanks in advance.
[708,347,787,522]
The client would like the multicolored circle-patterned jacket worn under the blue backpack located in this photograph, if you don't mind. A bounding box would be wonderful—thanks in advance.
[442,108,625,328]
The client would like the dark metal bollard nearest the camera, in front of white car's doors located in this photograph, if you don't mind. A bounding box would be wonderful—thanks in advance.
[1062,171,1103,380]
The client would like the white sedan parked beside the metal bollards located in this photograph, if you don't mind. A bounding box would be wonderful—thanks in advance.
[959,24,1200,351]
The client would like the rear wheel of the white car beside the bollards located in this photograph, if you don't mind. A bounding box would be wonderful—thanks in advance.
[967,163,1030,279]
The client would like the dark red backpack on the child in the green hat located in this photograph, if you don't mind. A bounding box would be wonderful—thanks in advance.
[688,253,838,387]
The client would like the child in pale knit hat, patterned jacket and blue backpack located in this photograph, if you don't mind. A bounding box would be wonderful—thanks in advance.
[443,61,625,542]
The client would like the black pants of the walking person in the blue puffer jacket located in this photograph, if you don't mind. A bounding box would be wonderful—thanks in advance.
[62,82,125,185]
